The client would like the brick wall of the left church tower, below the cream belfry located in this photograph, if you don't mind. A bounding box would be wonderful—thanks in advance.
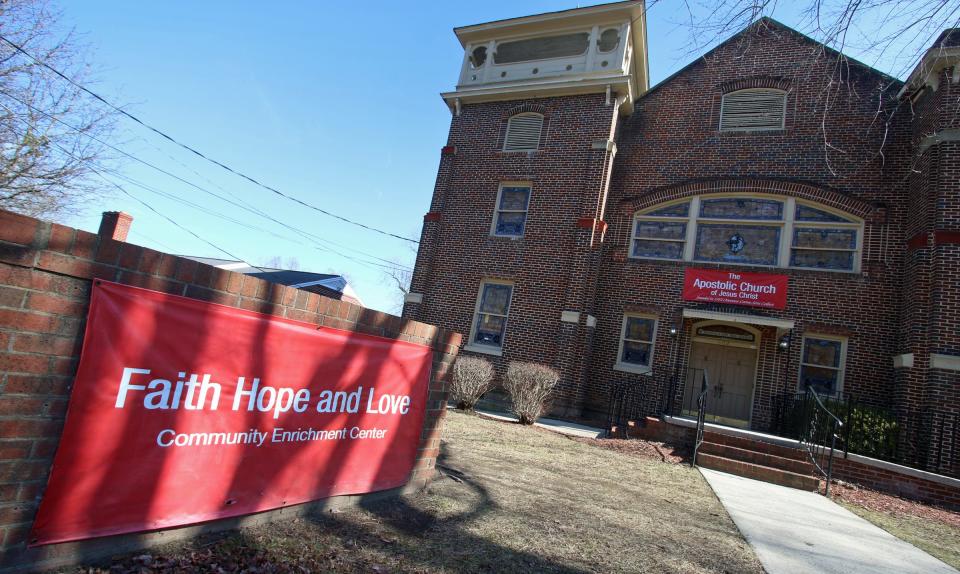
[404,94,617,412]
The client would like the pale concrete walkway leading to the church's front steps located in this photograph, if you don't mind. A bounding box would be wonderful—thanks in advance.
[700,468,957,574]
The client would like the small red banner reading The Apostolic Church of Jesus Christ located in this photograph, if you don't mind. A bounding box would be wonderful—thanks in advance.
[683,268,787,309]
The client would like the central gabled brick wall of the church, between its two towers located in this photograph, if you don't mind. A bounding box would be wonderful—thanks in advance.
[586,24,906,424]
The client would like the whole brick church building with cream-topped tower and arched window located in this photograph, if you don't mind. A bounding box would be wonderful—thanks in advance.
[403,2,960,472]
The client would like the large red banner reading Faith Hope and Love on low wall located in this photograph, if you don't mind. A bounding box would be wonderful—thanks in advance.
[31,282,431,544]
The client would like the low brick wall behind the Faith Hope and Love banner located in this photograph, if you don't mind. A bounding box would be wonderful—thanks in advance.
[0,211,461,569]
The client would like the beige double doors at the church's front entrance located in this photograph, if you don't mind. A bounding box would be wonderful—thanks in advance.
[688,341,757,428]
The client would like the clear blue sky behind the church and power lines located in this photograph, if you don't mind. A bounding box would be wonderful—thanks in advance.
[52,0,924,311]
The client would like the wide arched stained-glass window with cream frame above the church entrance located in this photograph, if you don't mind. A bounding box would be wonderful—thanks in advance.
[629,194,863,271]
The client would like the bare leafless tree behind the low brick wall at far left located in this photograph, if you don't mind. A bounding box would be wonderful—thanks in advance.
[0,0,116,218]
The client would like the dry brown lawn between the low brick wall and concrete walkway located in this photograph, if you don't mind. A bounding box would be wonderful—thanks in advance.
[65,412,763,573]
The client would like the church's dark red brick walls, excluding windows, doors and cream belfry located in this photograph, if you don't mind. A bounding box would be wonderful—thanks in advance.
[404,20,960,473]
